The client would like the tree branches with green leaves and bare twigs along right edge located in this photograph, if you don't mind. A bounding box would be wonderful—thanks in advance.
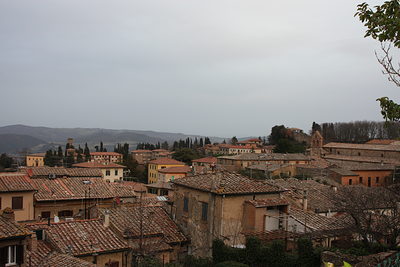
[356,0,400,121]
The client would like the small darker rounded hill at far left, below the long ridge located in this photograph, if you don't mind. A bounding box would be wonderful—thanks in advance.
[0,134,46,153]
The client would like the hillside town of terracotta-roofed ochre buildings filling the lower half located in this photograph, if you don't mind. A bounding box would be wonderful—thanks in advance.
[0,124,400,267]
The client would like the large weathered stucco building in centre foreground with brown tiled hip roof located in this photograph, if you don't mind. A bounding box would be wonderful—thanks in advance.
[173,172,283,257]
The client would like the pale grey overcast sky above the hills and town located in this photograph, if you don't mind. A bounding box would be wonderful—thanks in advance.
[0,0,400,136]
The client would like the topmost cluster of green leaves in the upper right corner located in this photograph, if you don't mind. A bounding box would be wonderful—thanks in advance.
[355,0,400,48]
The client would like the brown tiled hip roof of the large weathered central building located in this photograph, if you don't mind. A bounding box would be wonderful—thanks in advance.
[173,172,283,195]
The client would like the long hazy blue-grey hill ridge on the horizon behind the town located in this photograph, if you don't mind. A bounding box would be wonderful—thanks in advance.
[0,125,228,153]
